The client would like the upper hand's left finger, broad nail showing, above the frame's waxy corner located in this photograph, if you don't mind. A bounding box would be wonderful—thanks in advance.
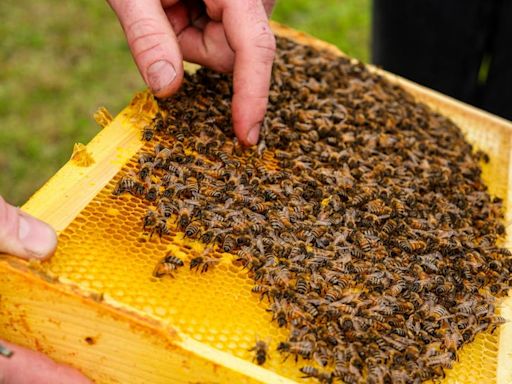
[109,0,183,97]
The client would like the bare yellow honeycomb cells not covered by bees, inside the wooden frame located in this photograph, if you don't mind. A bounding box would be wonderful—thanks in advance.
[39,127,508,383]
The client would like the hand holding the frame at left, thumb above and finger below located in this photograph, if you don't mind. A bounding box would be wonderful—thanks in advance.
[0,196,90,384]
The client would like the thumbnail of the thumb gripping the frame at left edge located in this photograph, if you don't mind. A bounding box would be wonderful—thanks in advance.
[18,212,57,259]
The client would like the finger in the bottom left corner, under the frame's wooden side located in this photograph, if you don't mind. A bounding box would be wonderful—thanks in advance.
[0,341,91,384]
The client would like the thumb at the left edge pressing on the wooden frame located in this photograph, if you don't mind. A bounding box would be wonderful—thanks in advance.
[0,196,57,259]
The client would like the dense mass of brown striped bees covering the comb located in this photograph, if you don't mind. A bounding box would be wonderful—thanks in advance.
[114,38,512,383]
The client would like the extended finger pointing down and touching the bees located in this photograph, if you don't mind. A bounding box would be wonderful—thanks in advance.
[216,0,276,145]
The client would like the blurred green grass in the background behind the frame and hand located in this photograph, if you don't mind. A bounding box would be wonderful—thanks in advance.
[0,0,370,204]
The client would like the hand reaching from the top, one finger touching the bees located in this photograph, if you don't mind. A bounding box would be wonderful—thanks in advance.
[109,0,275,145]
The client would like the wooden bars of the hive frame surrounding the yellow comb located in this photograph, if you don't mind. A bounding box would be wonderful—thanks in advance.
[0,24,512,383]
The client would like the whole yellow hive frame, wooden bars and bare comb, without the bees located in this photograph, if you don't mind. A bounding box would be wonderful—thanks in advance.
[0,25,512,384]
